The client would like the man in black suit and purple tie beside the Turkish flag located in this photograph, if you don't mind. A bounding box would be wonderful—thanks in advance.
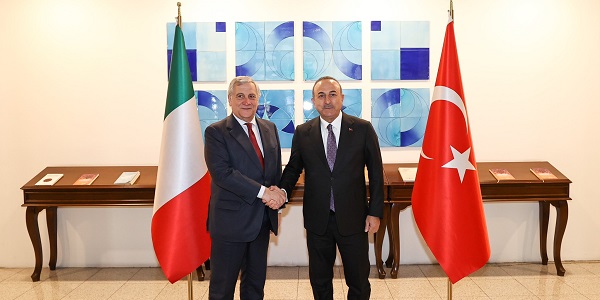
[279,76,383,299]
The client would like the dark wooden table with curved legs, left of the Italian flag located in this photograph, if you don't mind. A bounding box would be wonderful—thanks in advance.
[21,166,157,281]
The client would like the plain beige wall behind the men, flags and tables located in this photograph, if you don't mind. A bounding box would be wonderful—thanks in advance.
[0,0,600,271]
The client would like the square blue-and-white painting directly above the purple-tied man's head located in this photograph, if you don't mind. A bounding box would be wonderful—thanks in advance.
[302,21,363,81]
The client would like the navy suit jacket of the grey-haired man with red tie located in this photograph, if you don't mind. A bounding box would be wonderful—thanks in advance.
[204,115,281,242]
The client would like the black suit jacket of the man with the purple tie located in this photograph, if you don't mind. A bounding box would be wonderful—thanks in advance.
[279,113,383,235]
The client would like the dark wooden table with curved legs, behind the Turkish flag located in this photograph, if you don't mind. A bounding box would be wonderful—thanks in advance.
[375,162,571,278]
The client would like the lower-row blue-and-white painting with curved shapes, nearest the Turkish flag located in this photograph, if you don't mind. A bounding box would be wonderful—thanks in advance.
[371,88,429,147]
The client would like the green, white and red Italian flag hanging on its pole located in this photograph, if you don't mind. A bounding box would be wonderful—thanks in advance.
[152,25,210,283]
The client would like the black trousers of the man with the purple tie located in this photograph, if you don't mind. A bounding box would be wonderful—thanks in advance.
[306,213,371,300]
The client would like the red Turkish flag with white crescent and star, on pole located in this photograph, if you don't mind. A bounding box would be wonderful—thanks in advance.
[412,14,490,283]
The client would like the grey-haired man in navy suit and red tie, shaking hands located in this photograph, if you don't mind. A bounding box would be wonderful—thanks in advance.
[204,76,285,300]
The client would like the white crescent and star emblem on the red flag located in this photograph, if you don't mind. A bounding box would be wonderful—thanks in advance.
[421,86,475,182]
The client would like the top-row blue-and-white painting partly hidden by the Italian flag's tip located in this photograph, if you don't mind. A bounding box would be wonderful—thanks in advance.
[167,22,227,82]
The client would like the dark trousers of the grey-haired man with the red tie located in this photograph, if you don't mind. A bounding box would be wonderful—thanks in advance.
[208,211,271,300]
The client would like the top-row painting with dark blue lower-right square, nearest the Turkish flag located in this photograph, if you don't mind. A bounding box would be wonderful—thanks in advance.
[371,21,429,80]
